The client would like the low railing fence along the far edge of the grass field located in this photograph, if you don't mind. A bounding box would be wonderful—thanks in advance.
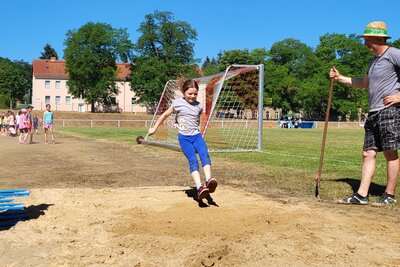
[55,119,364,129]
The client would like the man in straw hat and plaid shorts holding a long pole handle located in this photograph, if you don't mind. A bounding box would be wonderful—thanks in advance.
[329,21,400,207]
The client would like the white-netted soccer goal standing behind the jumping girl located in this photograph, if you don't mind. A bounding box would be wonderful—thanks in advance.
[143,65,264,152]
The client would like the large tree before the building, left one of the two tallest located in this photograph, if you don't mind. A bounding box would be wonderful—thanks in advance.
[64,22,133,112]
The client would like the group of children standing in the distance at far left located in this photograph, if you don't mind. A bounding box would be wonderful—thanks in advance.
[0,104,55,144]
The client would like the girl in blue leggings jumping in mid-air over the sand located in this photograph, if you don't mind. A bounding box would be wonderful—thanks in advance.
[148,80,217,200]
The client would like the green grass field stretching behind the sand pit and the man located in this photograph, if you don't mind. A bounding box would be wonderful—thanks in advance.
[57,127,396,206]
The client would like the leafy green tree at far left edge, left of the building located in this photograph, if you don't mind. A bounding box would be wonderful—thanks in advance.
[0,58,32,109]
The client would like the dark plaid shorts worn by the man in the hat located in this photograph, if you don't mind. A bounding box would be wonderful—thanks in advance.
[363,106,400,151]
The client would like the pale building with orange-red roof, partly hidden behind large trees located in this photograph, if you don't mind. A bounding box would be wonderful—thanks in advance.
[32,58,147,113]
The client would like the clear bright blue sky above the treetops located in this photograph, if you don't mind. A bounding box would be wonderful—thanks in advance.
[0,0,400,62]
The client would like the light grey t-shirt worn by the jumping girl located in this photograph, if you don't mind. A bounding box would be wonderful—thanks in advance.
[172,97,203,135]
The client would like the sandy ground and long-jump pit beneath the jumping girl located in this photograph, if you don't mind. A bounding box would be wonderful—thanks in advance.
[0,133,400,266]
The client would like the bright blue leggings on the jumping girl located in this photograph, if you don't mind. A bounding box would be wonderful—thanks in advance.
[178,134,211,173]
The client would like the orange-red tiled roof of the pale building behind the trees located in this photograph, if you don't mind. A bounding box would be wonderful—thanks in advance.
[32,59,130,80]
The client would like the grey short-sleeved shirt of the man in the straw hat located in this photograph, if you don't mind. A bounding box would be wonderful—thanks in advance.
[368,47,400,111]
